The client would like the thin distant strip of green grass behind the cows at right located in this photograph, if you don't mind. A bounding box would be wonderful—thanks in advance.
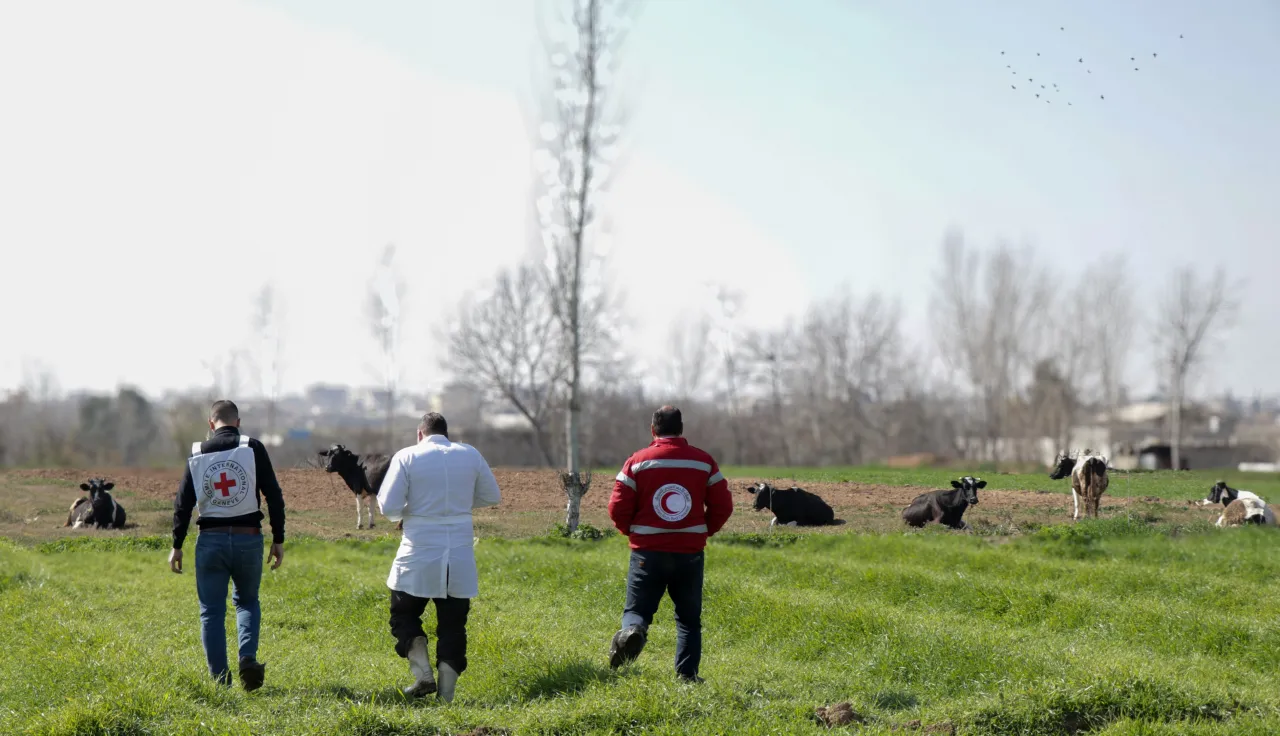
[724,466,1280,502]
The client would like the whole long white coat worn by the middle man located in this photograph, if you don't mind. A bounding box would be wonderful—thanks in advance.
[378,434,502,598]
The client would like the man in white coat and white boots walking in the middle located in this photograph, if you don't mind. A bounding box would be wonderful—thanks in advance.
[378,412,502,701]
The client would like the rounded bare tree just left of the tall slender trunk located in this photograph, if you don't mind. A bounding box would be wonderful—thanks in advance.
[449,264,566,465]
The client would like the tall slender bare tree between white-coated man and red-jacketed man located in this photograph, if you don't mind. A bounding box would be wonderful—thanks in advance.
[538,0,628,531]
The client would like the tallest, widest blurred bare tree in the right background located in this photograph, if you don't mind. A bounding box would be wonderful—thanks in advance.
[931,233,1052,456]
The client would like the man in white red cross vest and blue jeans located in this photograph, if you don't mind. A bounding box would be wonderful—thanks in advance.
[169,401,284,690]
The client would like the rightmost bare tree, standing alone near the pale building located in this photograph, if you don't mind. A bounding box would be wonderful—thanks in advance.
[1152,266,1239,470]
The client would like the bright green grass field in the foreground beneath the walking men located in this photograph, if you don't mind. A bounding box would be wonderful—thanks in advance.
[0,522,1280,736]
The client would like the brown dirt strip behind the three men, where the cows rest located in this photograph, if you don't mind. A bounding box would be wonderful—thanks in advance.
[0,468,1220,539]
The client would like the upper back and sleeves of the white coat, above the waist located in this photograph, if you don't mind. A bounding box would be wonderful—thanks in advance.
[378,435,502,521]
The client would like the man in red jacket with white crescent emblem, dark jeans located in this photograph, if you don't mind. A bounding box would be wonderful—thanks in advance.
[609,406,733,682]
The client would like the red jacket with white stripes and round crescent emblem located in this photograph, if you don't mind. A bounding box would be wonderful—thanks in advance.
[609,436,733,553]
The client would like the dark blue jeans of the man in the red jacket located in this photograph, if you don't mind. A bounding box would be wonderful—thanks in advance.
[622,549,705,677]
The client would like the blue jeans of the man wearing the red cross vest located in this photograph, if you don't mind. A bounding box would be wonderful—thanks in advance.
[196,531,264,684]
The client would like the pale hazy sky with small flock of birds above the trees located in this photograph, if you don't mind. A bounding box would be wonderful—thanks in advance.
[0,0,1280,404]
